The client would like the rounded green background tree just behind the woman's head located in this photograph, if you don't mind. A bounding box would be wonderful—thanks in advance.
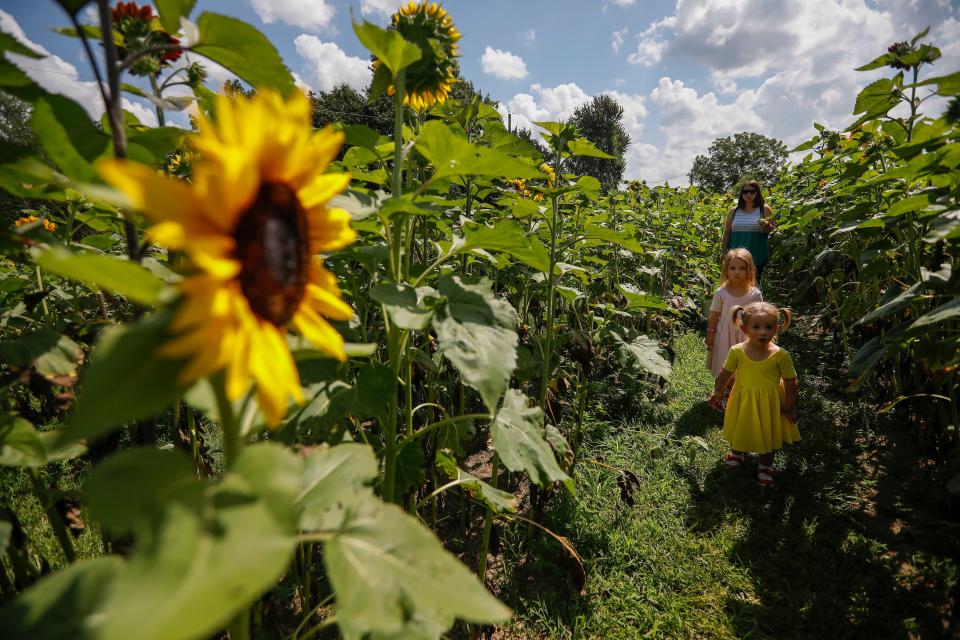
[690,132,787,193]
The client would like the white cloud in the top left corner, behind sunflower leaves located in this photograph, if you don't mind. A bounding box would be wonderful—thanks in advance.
[0,9,157,126]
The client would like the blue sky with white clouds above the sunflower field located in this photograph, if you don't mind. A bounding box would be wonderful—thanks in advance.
[0,0,960,184]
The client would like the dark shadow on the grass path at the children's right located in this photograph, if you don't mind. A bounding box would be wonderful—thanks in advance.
[691,324,949,638]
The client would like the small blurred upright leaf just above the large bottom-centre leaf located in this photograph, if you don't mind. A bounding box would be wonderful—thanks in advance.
[296,443,378,531]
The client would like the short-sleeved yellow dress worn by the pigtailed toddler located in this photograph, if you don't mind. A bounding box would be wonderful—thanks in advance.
[723,343,800,454]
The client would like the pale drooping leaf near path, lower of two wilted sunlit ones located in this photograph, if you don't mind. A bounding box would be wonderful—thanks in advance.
[490,389,573,492]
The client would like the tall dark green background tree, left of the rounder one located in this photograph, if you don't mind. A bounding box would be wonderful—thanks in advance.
[568,95,630,192]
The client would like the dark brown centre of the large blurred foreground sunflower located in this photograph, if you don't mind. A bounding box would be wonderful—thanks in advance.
[233,183,310,326]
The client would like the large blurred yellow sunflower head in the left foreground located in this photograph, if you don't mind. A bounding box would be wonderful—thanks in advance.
[97,91,356,427]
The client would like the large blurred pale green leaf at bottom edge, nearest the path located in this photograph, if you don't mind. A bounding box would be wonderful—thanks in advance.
[324,497,510,640]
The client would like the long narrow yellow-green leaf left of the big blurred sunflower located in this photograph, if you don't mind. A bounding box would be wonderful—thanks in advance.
[33,247,166,306]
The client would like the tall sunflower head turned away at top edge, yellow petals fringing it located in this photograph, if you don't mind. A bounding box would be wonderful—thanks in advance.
[374,2,460,111]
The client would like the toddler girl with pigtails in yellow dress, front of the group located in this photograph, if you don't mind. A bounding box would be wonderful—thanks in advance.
[708,302,800,487]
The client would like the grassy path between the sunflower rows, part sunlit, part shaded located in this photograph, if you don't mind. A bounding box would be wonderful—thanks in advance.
[495,334,957,638]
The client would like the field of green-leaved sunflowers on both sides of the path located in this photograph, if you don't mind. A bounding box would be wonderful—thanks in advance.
[0,0,960,640]
